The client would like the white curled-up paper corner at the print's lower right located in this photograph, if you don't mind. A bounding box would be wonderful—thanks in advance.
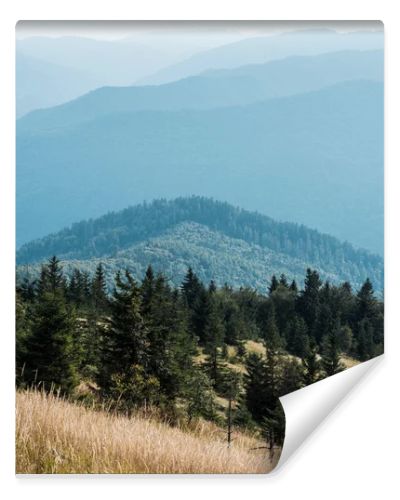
[272,355,384,473]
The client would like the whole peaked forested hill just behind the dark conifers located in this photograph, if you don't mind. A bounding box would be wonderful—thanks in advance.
[17,196,383,292]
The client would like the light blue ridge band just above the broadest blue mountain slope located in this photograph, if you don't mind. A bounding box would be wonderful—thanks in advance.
[18,50,383,132]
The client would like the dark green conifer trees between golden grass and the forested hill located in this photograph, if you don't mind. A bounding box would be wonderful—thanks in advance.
[16,257,383,446]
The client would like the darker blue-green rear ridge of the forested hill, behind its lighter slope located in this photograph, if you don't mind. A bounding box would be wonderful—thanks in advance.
[17,196,383,292]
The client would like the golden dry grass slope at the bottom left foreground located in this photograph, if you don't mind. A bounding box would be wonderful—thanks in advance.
[16,391,278,474]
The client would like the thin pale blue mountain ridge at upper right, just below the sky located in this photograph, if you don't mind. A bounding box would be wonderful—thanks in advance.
[137,30,384,85]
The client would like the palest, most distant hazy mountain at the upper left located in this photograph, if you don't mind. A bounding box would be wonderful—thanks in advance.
[16,29,256,117]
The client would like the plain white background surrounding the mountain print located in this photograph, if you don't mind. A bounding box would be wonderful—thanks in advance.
[0,0,400,500]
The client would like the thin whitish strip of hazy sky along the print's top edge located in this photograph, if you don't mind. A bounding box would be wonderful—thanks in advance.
[16,21,383,40]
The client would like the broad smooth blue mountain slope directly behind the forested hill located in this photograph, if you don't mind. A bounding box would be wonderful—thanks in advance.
[17,81,383,252]
